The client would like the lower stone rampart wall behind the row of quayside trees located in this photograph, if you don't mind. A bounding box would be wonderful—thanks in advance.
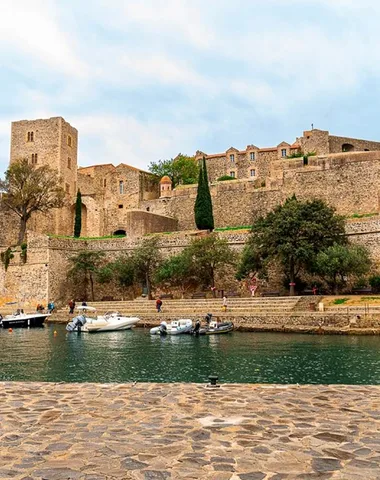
[0,216,380,307]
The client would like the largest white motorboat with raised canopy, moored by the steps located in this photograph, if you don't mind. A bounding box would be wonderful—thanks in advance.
[66,305,140,333]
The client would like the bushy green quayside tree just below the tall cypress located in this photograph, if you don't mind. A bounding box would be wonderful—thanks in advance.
[185,234,236,287]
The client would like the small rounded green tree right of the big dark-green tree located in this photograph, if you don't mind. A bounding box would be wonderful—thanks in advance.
[314,244,371,295]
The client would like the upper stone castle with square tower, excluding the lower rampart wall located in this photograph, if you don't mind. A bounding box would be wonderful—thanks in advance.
[0,117,380,245]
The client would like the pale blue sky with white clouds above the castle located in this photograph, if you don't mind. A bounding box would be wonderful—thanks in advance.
[0,0,380,175]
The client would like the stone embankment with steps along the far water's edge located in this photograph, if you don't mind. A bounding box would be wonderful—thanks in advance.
[50,296,380,335]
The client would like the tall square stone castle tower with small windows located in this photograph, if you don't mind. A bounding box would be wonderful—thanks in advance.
[10,117,78,234]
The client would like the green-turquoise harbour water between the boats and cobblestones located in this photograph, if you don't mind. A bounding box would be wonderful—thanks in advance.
[0,325,380,385]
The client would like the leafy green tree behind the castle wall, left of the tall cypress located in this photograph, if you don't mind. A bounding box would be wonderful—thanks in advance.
[149,153,199,188]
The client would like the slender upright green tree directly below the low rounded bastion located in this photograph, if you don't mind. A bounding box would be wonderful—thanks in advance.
[132,237,161,299]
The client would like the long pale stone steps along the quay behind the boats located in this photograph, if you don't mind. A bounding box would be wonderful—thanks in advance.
[57,297,300,316]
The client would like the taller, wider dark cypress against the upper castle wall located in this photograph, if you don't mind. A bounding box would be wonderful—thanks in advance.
[194,157,214,230]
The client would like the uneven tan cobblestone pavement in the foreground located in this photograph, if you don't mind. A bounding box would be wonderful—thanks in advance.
[0,382,380,480]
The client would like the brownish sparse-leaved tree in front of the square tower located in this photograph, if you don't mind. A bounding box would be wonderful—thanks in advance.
[0,159,65,245]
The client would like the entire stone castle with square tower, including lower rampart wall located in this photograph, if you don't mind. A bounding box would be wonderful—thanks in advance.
[0,117,380,304]
